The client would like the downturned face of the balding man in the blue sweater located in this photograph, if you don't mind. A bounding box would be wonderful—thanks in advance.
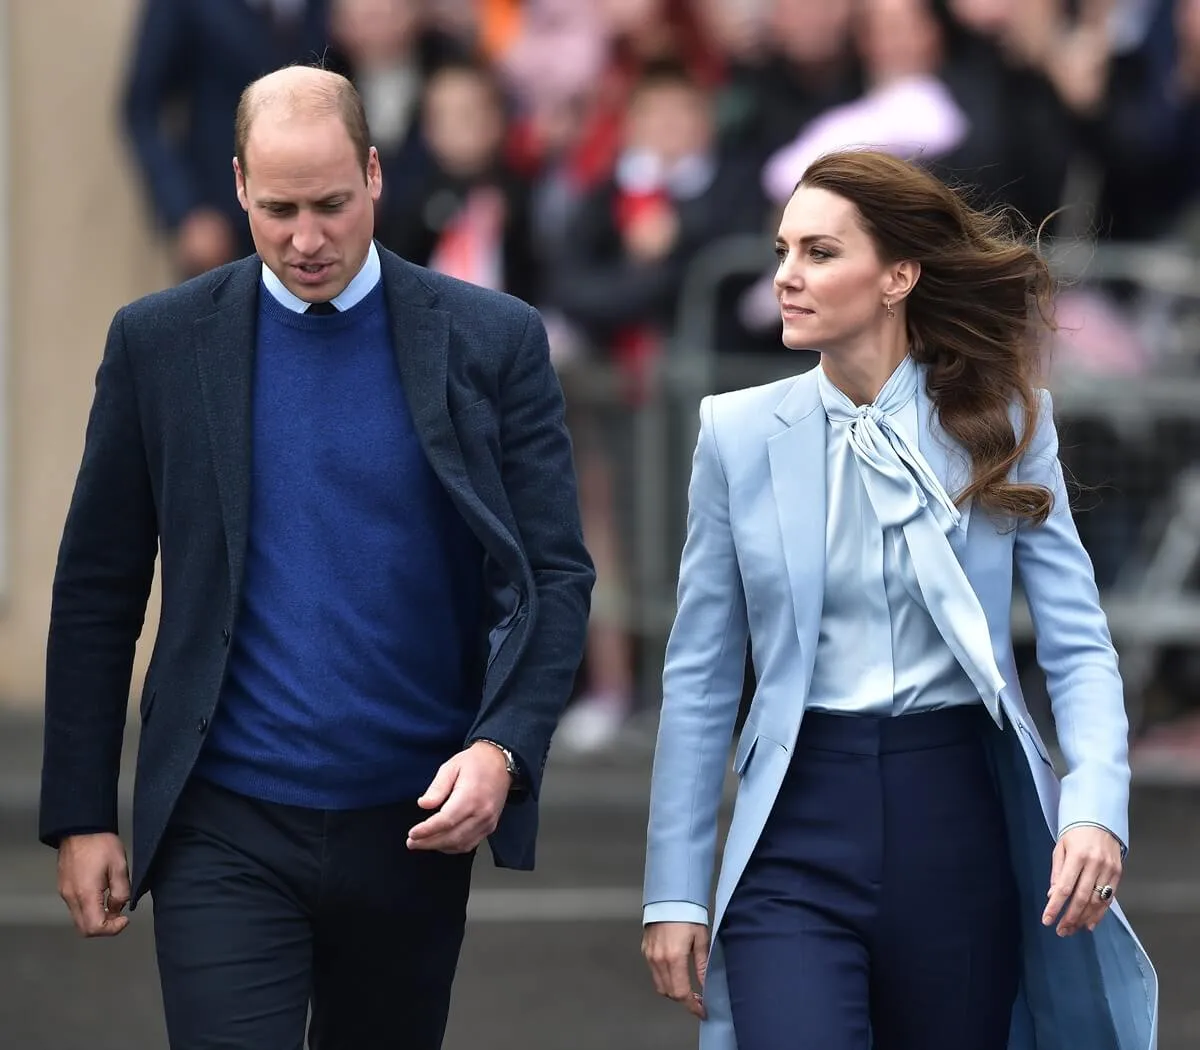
[234,110,383,302]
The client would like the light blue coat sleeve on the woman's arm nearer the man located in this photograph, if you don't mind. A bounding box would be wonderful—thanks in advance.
[642,397,749,924]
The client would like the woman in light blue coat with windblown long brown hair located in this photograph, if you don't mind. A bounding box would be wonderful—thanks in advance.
[643,151,1158,1050]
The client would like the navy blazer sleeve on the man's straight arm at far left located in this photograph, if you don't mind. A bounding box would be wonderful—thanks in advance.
[40,306,158,845]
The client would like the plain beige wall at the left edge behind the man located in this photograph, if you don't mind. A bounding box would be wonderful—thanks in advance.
[0,0,174,709]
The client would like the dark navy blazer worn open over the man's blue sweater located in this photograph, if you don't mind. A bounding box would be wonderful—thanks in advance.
[40,248,594,901]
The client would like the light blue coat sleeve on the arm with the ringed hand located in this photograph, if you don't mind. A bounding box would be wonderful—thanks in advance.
[1015,390,1129,844]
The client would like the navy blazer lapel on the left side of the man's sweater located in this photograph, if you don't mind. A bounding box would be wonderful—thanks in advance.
[193,257,262,608]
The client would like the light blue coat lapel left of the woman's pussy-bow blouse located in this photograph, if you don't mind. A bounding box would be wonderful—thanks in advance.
[767,372,826,672]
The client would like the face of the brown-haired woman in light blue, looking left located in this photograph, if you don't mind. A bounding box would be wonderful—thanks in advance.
[775,186,913,352]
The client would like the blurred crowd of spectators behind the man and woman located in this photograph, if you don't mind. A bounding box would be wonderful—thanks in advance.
[122,0,1200,754]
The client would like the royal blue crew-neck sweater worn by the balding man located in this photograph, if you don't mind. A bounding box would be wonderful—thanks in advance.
[197,277,482,809]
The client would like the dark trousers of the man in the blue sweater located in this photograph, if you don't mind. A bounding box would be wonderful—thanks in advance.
[150,778,473,1050]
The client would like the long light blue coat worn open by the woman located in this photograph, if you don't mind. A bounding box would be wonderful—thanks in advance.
[643,372,1158,1050]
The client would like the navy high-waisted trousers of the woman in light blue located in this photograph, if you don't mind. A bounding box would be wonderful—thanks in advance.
[719,707,1020,1050]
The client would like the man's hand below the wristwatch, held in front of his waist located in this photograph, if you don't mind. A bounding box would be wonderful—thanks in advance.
[408,740,512,853]
